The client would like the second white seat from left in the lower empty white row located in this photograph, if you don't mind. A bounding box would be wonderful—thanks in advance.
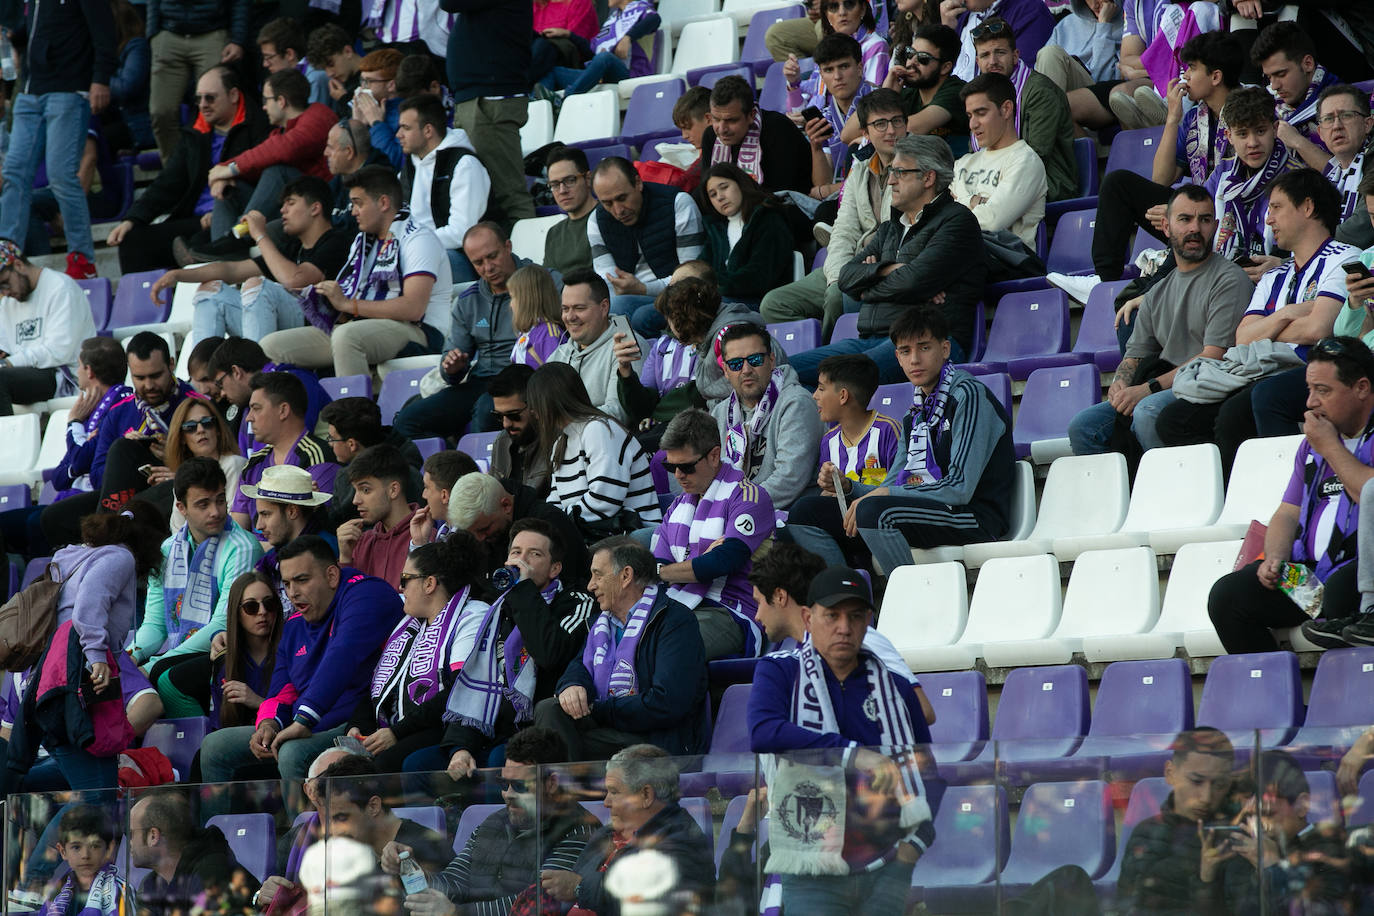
[912,553,1062,672]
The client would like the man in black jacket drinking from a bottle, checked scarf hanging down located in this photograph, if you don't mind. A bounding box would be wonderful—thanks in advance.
[425,519,595,779]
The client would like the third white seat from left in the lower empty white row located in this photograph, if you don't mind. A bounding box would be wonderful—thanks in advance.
[982,547,1160,666]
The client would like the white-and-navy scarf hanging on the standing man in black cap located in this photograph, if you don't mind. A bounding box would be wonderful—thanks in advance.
[764,634,932,875]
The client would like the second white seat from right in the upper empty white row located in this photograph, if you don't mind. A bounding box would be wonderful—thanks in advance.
[1052,442,1221,560]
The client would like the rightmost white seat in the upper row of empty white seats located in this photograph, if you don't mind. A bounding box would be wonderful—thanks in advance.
[1150,435,1303,553]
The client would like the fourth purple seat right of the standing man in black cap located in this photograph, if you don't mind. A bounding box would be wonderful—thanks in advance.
[1197,652,1303,757]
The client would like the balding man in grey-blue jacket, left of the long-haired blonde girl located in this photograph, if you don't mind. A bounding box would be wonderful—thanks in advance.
[396,221,532,439]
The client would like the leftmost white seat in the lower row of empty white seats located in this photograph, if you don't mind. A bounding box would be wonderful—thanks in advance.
[878,563,969,667]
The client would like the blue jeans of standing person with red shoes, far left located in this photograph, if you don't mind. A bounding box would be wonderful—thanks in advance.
[0,92,95,258]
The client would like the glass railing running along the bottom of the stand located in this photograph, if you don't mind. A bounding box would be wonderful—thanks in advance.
[4,729,1374,916]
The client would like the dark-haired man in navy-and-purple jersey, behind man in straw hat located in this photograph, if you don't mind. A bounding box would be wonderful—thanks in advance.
[229,372,339,530]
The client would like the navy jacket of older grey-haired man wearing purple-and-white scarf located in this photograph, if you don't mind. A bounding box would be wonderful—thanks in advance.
[555,588,709,757]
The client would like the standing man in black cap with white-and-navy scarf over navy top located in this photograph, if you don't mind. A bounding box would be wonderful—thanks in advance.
[749,566,940,912]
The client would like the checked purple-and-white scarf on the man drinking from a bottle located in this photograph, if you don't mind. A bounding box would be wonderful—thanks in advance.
[444,580,563,737]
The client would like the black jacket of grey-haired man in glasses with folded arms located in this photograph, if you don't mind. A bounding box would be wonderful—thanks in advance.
[840,191,985,354]
